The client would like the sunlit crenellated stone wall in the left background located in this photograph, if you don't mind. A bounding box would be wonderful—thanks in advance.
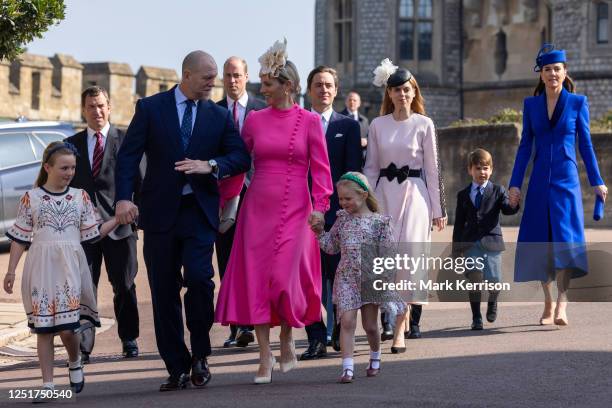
[0,53,223,127]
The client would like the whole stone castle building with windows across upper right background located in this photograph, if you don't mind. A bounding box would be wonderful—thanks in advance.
[315,0,612,126]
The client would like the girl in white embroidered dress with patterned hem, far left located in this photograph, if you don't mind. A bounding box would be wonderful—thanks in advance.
[4,142,117,395]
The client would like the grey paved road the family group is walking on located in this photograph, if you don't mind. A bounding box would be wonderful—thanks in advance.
[0,230,612,408]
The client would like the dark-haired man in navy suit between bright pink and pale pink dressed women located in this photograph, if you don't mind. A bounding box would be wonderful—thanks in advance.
[300,66,361,360]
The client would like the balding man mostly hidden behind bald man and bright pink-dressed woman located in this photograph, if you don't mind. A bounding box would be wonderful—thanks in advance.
[215,57,266,347]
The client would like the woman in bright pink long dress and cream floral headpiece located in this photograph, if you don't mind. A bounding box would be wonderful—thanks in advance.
[215,42,333,384]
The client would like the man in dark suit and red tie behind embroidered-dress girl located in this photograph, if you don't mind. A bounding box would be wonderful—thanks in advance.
[66,86,140,362]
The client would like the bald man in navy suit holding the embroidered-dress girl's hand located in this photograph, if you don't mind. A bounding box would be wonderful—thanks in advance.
[115,51,251,391]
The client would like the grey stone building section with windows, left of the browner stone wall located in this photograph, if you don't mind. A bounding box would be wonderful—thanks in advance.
[315,0,461,124]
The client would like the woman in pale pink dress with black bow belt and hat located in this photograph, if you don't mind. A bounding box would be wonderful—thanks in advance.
[363,59,446,353]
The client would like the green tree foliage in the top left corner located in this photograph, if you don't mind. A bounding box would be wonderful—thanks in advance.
[0,0,66,60]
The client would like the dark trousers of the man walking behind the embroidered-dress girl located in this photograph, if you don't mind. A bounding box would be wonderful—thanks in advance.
[83,234,139,341]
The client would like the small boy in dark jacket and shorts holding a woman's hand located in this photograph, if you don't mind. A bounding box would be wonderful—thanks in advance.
[453,149,519,330]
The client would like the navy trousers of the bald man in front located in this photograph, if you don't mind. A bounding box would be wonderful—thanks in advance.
[144,194,216,375]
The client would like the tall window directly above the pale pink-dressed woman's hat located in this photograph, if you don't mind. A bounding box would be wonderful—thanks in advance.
[398,0,433,61]
